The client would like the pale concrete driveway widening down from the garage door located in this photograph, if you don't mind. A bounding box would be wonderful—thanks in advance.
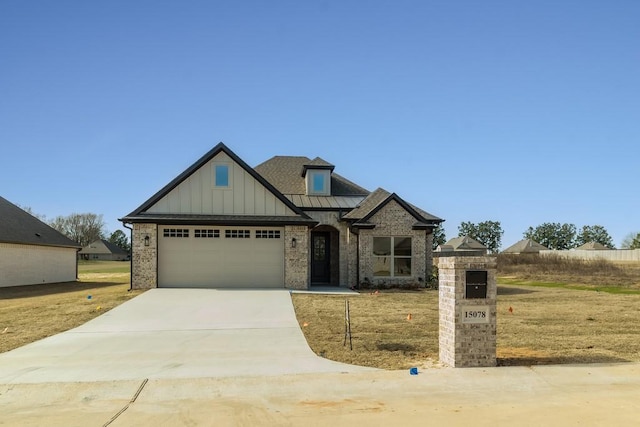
[0,289,371,384]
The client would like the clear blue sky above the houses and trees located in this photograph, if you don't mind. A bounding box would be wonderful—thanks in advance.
[0,0,640,248]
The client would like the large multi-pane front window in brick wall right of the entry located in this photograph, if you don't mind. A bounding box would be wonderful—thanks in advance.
[373,237,411,277]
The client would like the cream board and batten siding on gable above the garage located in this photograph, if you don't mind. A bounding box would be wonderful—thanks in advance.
[147,152,294,216]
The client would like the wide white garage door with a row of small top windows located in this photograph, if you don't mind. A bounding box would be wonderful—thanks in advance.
[158,226,284,288]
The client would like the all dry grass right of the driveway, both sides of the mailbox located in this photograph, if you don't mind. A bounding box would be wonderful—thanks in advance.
[293,280,640,369]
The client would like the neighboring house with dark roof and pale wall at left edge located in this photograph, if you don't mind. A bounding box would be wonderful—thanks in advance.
[0,197,80,287]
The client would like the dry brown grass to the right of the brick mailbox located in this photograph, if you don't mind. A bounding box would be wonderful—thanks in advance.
[498,285,640,365]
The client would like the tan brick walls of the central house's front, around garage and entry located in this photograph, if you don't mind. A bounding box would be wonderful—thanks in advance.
[131,206,432,289]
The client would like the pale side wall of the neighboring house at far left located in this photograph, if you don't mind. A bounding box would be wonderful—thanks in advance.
[0,243,77,287]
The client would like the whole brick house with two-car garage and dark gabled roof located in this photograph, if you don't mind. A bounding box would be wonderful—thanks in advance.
[120,143,443,289]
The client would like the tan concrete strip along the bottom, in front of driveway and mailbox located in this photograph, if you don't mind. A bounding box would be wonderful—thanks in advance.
[0,363,640,427]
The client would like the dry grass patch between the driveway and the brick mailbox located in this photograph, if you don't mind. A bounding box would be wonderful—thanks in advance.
[292,290,438,369]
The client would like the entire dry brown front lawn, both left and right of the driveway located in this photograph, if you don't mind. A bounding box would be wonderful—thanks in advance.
[5,261,640,369]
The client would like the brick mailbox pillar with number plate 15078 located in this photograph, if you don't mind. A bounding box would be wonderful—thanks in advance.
[438,256,497,368]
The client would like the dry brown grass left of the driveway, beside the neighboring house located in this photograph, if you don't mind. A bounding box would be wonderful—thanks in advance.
[0,261,141,352]
